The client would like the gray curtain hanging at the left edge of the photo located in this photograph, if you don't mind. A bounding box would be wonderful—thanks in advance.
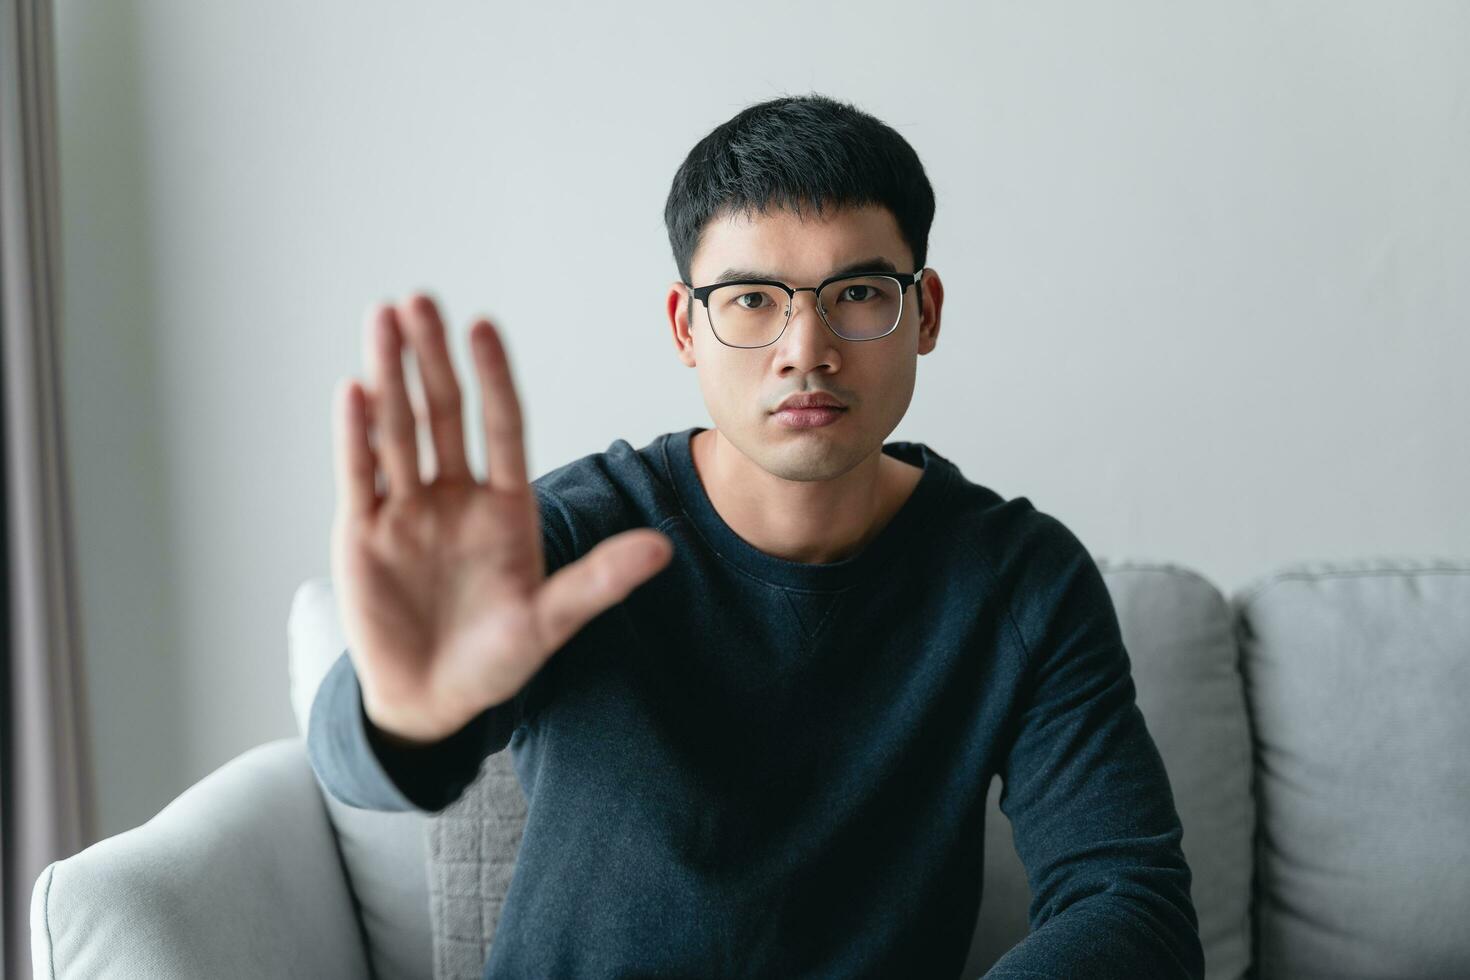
[0,0,94,977]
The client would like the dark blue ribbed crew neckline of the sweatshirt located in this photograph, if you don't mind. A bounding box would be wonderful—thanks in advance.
[663,426,954,592]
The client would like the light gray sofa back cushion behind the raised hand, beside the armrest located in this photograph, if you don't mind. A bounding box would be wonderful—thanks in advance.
[287,577,434,980]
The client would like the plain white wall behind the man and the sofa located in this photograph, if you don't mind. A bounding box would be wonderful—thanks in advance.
[57,0,1470,835]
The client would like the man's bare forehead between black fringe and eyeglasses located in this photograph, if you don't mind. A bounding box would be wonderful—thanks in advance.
[689,204,913,285]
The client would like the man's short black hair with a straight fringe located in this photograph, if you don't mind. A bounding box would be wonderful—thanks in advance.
[663,93,933,310]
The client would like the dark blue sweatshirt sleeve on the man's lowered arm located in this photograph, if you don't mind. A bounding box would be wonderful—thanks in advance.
[985,511,1204,980]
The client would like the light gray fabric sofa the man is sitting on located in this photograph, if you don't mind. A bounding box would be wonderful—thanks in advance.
[31,558,1470,980]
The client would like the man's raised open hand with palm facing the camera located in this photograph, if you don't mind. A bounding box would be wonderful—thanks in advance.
[331,294,673,745]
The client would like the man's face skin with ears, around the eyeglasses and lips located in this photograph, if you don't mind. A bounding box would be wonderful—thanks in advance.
[669,206,942,480]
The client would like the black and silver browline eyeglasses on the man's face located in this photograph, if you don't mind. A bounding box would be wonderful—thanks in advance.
[685,269,923,348]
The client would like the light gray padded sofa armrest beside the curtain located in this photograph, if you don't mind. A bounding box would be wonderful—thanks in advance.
[31,736,368,980]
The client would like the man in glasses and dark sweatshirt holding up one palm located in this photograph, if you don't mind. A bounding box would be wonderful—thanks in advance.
[309,96,1204,977]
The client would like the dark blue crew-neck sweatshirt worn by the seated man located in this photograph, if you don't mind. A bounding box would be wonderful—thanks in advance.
[307,428,1204,980]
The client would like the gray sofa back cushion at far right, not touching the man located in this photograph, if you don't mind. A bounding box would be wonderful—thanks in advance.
[1232,560,1470,977]
